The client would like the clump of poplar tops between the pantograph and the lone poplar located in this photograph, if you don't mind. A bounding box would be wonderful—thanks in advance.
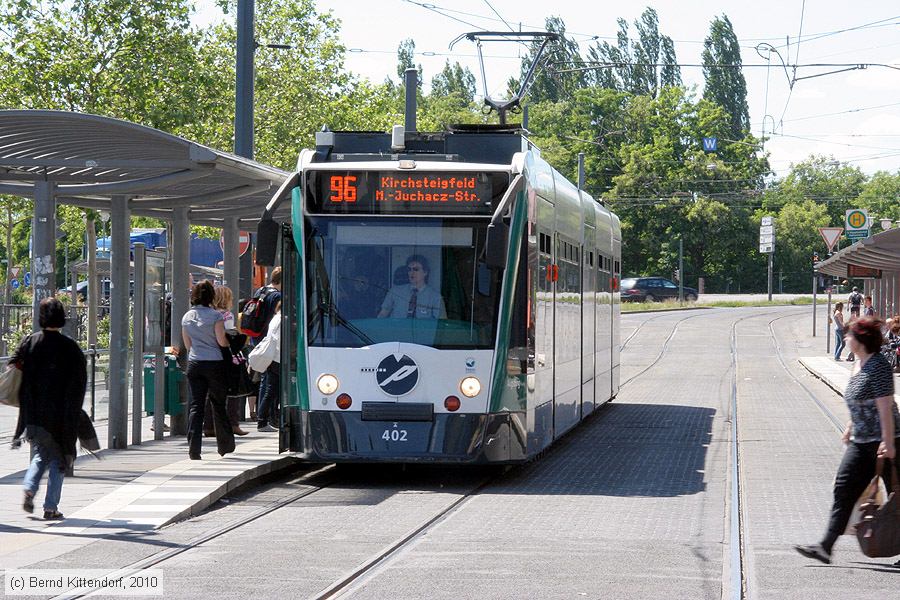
[588,7,681,97]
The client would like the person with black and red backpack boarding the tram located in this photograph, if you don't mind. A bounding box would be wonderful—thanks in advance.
[241,267,281,432]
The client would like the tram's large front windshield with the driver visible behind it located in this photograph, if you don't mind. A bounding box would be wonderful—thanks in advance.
[305,217,500,349]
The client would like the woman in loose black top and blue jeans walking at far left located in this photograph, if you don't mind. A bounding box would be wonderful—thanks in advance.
[10,298,87,520]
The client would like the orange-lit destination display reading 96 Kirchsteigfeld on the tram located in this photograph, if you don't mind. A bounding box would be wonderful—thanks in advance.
[306,170,509,215]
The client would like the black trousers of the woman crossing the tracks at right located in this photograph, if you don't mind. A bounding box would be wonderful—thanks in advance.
[822,438,900,554]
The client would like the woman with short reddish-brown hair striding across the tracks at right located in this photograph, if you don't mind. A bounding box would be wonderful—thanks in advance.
[794,317,900,564]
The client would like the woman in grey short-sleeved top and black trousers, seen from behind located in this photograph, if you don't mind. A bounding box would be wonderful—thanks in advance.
[181,279,234,460]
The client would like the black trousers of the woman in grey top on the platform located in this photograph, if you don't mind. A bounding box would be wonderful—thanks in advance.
[187,360,234,457]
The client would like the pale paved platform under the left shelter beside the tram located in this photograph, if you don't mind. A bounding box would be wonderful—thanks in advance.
[0,417,296,569]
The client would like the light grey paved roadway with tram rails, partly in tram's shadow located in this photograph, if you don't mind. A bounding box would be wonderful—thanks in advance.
[15,307,900,600]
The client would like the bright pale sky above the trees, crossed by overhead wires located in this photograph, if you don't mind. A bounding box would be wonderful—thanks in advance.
[195,0,900,177]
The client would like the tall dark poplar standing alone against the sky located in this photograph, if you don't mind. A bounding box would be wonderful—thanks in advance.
[703,15,750,140]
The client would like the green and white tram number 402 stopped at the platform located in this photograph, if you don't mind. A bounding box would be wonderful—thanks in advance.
[259,126,621,463]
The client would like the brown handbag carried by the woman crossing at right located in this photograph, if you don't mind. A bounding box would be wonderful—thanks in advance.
[856,458,900,558]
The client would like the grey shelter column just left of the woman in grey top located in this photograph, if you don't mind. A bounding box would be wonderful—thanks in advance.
[170,208,191,435]
